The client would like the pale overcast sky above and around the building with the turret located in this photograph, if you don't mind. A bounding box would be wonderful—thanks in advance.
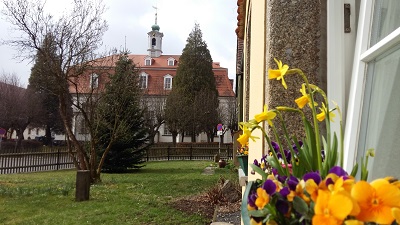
[0,0,237,86]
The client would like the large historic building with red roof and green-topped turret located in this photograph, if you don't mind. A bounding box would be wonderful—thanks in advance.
[70,20,236,143]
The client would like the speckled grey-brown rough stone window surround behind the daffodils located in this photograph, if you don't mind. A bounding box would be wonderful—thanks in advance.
[265,0,326,142]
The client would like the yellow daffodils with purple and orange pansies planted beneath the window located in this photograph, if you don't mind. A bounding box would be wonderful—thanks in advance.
[238,59,400,225]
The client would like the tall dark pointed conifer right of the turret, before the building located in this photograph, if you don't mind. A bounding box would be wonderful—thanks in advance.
[166,24,218,142]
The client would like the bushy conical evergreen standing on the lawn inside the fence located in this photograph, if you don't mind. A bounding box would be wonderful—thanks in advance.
[94,52,149,172]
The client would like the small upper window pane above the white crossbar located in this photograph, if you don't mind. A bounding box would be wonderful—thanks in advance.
[370,0,400,46]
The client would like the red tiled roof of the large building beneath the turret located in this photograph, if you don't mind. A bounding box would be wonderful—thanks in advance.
[76,54,235,97]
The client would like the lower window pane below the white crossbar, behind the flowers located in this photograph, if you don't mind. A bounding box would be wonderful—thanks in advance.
[357,45,400,179]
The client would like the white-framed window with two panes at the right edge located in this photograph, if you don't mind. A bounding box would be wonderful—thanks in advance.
[345,0,400,179]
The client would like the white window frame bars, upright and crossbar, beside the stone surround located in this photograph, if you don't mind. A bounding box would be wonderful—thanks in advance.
[344,0,400,171]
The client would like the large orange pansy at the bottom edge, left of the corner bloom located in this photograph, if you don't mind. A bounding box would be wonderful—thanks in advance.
[312,190,353,225]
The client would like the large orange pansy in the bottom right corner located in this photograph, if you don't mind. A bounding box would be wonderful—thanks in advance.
[351,179,400,224]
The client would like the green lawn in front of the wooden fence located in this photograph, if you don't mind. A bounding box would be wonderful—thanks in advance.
[0,161,238,225]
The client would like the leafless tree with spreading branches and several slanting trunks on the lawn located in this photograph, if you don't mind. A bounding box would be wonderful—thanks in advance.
[2,0,107,182]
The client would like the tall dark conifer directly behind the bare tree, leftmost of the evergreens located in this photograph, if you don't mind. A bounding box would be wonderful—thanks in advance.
[28,34,67,144]
